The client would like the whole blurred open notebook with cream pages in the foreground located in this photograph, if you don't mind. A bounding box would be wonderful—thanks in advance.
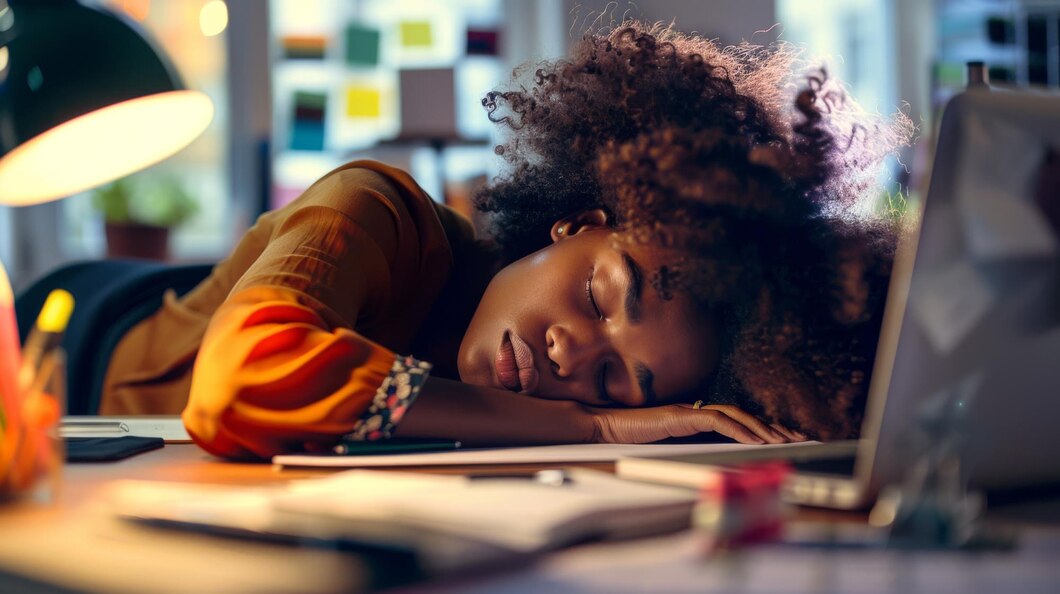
[107,469,696,570]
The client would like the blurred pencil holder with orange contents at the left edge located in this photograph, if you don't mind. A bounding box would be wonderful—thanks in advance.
[0,349,66,503]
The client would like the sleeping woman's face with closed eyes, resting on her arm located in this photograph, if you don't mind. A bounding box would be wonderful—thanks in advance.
[458,211,718,406]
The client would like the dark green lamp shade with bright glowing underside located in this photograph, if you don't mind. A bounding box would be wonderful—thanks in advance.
[0,0,213,205]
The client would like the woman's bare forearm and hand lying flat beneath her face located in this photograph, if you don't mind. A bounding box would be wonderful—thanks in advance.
[394,378,792,446]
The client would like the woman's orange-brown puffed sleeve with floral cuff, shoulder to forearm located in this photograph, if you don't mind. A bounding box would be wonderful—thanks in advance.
[182,167,429,458]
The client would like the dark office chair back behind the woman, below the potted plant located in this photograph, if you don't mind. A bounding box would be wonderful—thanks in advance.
[15,260,213,415]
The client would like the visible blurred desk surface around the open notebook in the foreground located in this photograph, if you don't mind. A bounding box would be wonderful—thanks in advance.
[0,444,1060,594]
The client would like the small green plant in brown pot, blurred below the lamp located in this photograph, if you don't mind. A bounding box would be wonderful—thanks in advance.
[92,176,198,260]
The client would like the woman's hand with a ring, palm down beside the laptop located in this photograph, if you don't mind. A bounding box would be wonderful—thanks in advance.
[590,404,807,443]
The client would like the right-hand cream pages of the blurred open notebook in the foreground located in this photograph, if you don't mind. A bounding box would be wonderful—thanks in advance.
[275,469,696,552]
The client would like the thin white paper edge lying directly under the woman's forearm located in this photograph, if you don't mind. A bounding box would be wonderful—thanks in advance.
[272,443,809,468]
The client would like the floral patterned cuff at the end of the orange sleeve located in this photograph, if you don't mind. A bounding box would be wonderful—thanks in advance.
[342,355,430,442]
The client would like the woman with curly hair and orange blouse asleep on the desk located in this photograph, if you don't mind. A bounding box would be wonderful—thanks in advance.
[101,21,909,458]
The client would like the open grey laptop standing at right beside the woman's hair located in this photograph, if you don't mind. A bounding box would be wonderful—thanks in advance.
[616,89,1060,509]
